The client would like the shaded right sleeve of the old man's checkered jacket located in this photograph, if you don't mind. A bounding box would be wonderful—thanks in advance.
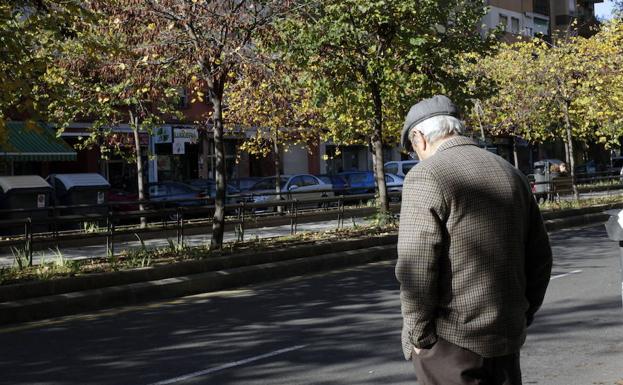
[525,198,552,325]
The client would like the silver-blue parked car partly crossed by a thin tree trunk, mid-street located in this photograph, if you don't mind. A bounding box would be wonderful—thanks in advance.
[249,174,334,211]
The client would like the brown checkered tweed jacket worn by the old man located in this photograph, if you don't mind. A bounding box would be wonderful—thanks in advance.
[396,136,552,359]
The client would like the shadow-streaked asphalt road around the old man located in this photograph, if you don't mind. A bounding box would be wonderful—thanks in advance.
[0,227,623,385]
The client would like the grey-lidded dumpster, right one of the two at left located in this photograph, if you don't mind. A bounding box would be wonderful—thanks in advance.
[48,173,110,224]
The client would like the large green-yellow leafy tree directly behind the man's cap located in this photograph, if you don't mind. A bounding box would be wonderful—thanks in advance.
[278,0,490,214]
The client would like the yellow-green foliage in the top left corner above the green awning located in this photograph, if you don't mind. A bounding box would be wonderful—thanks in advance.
[0,0,92,142]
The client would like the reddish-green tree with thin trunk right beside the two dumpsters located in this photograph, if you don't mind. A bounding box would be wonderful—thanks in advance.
[49,1,177,225]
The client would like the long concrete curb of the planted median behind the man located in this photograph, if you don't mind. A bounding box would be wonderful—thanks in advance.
[0,205,612,324]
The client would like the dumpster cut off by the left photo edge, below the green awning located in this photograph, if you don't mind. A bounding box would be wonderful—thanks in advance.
[0,175,53,235]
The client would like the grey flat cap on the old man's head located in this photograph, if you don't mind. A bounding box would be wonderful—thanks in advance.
[400,95,459,151]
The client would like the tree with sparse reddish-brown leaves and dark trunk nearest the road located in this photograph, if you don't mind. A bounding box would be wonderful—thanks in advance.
[106,0,293,248]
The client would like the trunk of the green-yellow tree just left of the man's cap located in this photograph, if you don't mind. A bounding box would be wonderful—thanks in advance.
[371,84,389,215]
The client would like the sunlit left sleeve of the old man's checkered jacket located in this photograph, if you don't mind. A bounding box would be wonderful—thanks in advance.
[396,165,446,348]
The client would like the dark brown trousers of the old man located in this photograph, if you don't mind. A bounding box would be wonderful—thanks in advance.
[411,338,521,385]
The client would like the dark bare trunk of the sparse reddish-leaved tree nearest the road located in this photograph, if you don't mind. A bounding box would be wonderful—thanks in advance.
[210,95,226,249]
